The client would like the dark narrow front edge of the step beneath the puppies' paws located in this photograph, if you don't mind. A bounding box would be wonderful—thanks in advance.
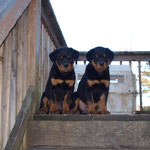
[34,112,150,122]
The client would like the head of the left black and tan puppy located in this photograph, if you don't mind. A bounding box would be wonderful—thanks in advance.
[49,47,79,72]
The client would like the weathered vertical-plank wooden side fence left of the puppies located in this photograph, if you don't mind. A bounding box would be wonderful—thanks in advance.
[0,0,66,149]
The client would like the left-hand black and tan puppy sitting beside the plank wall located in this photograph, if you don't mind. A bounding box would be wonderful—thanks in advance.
[40,47,79,114]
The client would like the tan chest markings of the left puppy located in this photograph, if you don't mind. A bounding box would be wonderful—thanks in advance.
[51,78,75,88]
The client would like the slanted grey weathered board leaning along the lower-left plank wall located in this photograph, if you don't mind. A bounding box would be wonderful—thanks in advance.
[5,86,34,150]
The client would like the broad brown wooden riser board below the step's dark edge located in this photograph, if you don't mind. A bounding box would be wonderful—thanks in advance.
[28,121,150,149]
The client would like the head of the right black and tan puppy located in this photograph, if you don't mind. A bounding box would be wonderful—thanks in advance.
[86,47,114,72]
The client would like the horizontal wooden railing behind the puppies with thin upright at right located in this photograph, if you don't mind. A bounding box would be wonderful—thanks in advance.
[78,51,150,111]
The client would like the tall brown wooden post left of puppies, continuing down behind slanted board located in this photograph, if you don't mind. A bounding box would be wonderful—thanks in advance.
[23,0,41,149]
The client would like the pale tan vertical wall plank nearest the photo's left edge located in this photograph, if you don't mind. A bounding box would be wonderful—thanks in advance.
[2,33,12,147]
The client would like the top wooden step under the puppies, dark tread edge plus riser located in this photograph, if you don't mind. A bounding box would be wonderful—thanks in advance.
[27,114,150,150]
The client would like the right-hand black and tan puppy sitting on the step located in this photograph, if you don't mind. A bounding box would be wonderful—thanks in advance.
[71,47,114,114]
